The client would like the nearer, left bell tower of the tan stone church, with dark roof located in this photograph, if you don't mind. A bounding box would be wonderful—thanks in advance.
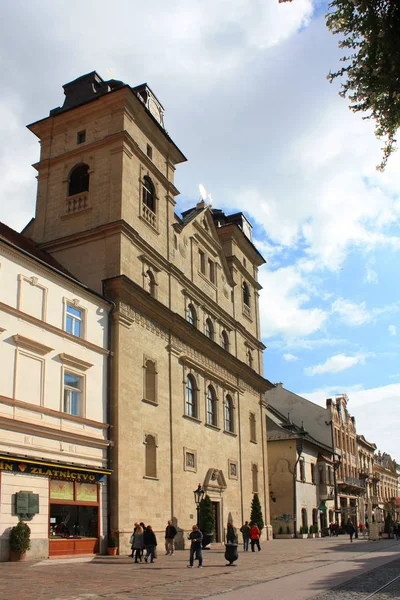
[24,71,186,291]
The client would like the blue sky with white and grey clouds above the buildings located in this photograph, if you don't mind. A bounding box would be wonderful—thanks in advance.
[0,0,400,460]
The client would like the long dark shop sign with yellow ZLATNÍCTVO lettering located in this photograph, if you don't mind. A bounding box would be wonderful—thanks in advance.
[0,459,104,483]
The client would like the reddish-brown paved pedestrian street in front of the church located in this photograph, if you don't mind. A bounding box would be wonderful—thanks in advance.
[0,537,400,600]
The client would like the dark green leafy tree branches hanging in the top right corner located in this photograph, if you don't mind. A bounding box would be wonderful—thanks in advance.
[326,0,400,171]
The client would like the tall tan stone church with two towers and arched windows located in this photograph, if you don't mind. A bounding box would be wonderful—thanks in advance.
[23,72,272,553]
